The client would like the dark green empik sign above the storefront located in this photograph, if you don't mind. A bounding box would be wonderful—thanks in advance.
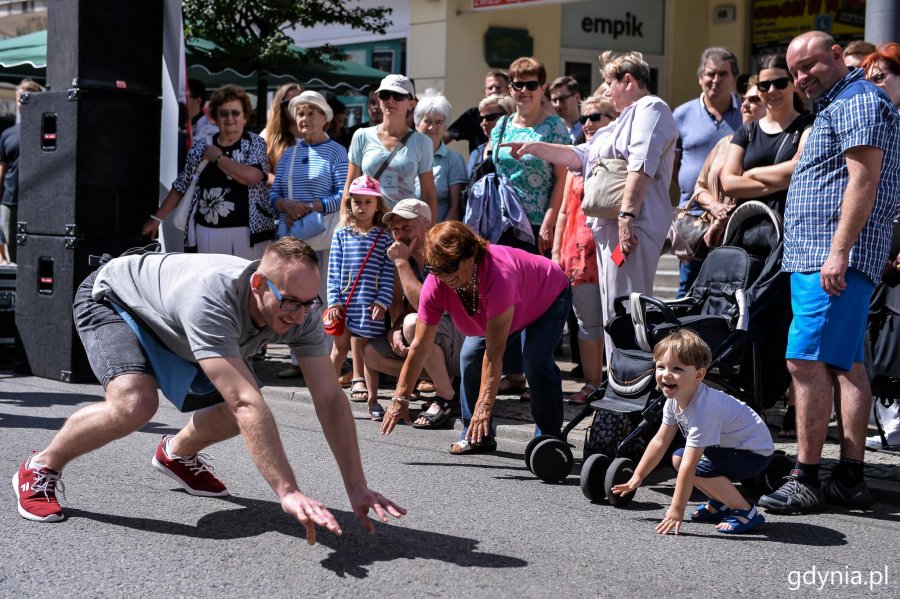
[562,0,666,54]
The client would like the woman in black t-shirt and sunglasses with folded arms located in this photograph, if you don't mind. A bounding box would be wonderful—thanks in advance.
[721,54,814,215]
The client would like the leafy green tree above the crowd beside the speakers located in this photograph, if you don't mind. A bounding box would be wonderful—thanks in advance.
[182,0,391,124]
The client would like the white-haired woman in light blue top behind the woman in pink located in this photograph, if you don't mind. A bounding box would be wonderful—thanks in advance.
[413,88,469,222]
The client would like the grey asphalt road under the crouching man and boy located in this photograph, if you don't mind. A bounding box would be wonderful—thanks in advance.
[0,374,900,598]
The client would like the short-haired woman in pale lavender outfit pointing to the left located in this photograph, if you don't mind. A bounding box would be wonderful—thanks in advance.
[500,52,678,355]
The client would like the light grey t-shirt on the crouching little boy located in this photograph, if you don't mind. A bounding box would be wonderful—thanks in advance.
[663,383,775,455]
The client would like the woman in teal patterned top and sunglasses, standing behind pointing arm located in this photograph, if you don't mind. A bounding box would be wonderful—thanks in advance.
[491,58,570,255]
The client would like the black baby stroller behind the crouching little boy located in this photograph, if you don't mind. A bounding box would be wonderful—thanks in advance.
[525,202,792,506]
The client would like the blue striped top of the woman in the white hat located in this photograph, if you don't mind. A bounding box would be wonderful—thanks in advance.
[269,139,347,214]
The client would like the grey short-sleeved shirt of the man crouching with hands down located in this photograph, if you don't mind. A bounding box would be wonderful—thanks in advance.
[93,253,328,362]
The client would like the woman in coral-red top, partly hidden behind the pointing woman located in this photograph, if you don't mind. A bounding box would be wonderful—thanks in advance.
[551,96,619,404]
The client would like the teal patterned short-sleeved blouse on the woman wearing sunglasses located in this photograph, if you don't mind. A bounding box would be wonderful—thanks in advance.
[491,115,571,226]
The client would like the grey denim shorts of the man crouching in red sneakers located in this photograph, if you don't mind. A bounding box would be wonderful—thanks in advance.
[72,271,153,389]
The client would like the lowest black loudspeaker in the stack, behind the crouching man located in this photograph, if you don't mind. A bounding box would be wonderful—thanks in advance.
[16,235,146,382]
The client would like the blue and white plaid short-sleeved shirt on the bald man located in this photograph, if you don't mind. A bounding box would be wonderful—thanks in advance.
[782,69,900,282]
